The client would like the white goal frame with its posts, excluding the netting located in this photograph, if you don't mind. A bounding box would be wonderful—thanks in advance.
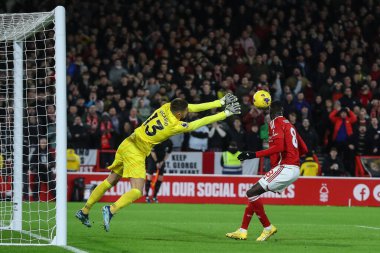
[0,6,67,246]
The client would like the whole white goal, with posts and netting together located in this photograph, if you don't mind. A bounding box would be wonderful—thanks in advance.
[0,7,66,245]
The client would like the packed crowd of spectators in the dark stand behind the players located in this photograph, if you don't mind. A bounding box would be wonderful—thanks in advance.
[11,0,380,175]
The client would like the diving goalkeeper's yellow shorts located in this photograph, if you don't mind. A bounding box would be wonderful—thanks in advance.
[108,134,151,179]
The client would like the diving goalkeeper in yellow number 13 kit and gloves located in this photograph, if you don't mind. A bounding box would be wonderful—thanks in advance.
[75,94,240,232]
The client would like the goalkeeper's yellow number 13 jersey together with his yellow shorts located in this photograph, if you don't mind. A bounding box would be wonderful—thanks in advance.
[108,100,226,178]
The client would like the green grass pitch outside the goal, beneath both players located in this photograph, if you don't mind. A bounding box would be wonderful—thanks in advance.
[0,203,380,253]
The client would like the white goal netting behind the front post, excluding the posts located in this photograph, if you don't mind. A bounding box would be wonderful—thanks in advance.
[0,12,56,244]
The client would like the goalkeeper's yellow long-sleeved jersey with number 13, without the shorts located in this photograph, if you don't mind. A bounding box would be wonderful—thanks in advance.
[135,100,226,150]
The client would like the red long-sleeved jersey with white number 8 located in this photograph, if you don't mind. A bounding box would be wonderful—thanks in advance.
[256,116,307,168]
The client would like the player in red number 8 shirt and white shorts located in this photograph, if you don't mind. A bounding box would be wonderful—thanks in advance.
[226,101,308,241]
